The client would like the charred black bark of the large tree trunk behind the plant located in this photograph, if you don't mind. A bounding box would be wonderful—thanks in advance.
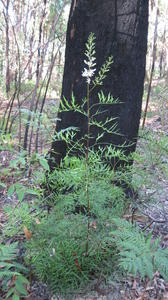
[51,0,148,167]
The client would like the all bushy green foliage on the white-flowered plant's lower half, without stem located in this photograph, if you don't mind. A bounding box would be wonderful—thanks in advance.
[26,153,127,292]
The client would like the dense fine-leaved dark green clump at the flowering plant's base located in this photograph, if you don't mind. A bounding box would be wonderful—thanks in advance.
[27,211,114,292]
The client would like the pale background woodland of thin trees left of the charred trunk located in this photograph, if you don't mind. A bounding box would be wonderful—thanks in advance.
[0,0,68,154]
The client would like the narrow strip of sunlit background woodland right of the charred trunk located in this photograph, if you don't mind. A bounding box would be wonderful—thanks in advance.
[142,0,168,128]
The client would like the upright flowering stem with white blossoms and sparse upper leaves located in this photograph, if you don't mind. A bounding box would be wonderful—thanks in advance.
[61,33,117,255]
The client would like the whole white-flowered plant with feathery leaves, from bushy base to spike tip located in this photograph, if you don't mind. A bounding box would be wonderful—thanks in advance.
[27,33,126,291]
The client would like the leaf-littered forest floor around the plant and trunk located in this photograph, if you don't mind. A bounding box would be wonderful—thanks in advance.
[0,81,168,300]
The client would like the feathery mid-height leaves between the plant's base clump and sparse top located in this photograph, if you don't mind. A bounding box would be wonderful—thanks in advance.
[45,152,125,219]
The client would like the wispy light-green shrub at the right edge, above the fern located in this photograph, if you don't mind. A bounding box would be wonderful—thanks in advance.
[132,130,168,192]
